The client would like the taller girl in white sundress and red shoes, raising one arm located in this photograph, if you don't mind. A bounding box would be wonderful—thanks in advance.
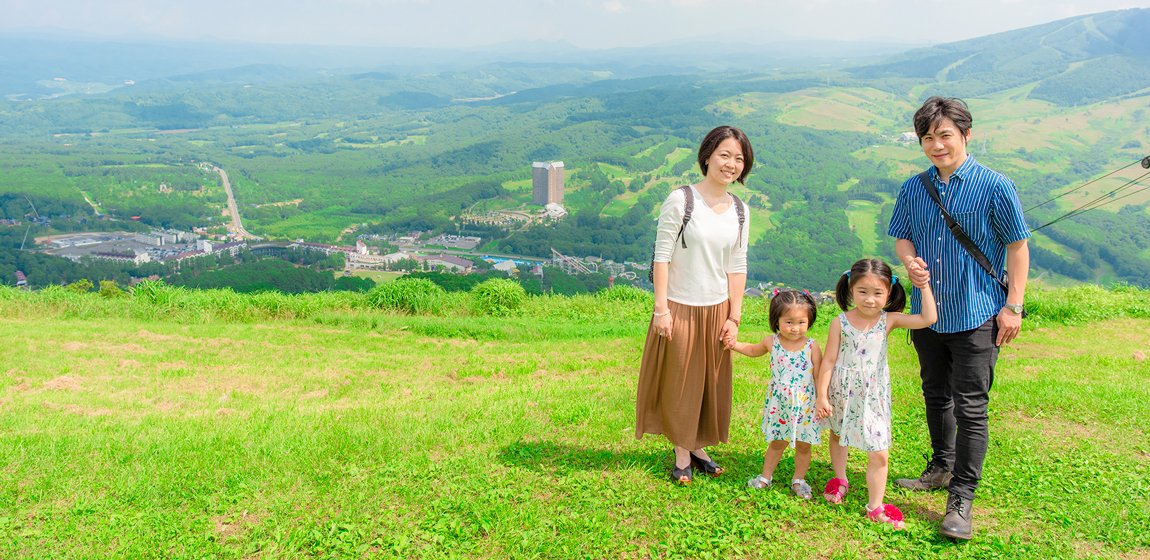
[817,259,938,529]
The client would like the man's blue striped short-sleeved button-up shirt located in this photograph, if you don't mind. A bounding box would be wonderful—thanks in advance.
[887,156,1030,332]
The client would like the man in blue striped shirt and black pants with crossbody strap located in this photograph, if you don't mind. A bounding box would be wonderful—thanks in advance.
[888,97,1030,540]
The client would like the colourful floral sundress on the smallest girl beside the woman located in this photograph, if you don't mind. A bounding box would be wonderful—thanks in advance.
[762,335,822,447]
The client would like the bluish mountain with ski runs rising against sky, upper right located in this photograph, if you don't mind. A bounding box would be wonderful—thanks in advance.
[851,9,1150,106]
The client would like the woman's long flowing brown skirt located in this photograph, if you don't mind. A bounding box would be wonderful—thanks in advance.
[635,301,731,450]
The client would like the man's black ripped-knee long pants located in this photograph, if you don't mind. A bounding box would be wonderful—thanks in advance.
[911,317,998,499]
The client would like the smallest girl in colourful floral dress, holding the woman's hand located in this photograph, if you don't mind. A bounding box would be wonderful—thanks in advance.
[731,290,821,500]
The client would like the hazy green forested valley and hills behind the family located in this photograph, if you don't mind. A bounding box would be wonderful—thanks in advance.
[0,9,1150,290]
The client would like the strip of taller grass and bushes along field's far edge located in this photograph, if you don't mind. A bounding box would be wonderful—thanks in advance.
[0,279,1150,331]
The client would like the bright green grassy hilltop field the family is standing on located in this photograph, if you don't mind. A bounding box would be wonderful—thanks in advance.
[0,287,1150,559]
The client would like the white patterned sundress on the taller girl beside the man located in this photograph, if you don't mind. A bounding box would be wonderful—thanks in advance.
[827,312,891,451]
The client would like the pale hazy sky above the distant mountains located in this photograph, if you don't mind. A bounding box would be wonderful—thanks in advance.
[0,0,1150,49]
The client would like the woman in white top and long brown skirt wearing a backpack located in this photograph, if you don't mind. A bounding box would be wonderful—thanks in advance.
[635,126,754,484]
